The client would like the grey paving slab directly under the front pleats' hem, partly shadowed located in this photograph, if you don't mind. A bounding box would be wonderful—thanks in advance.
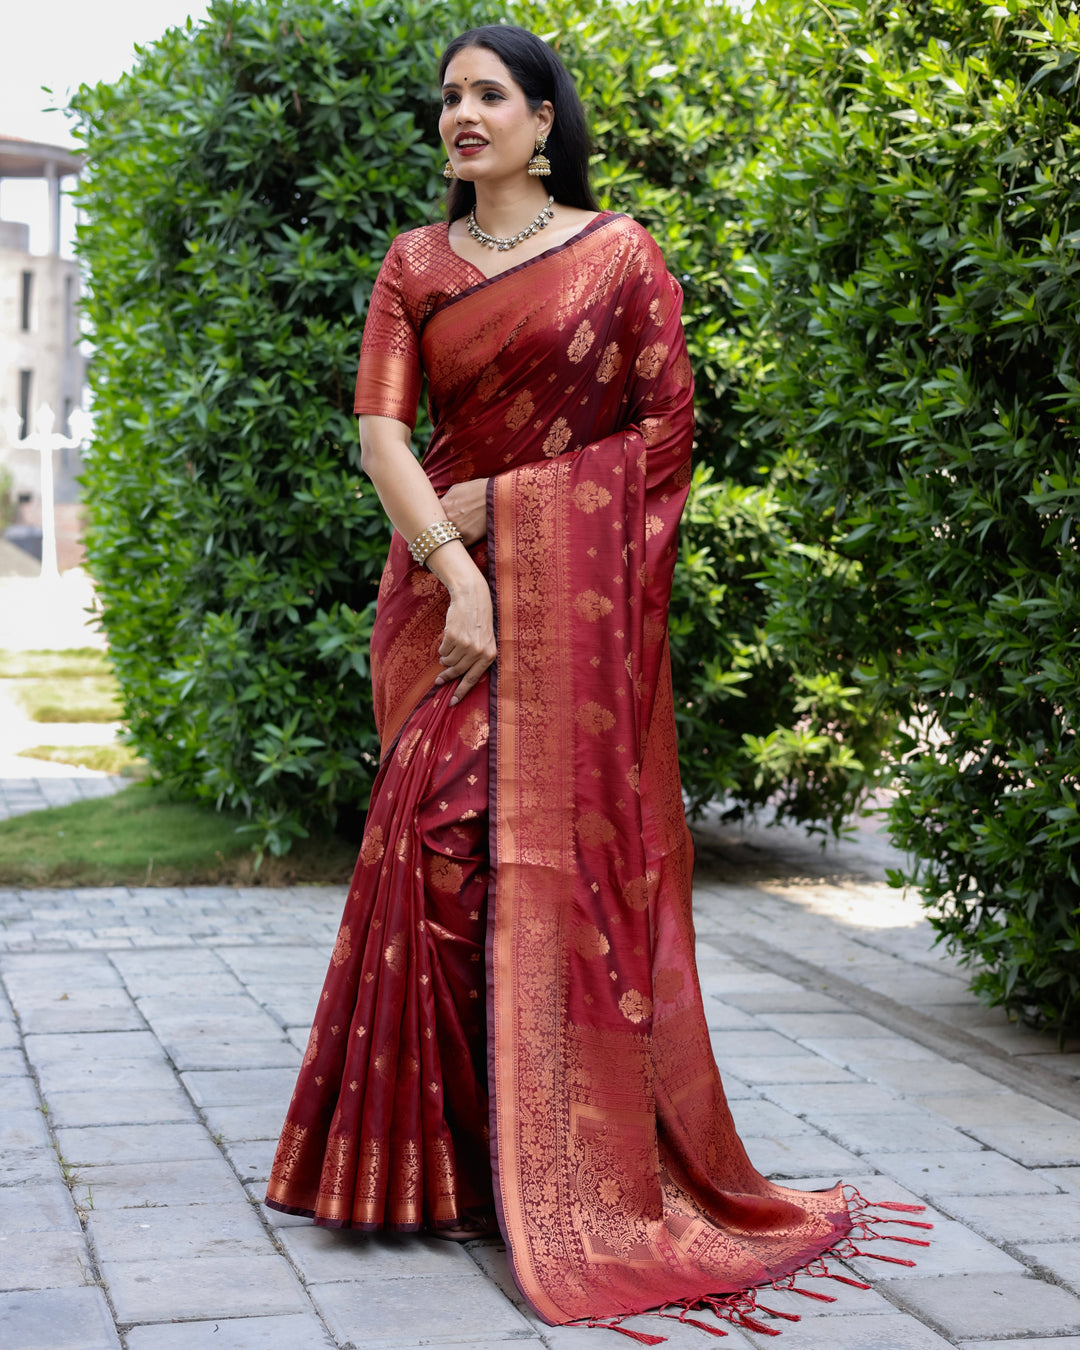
[271,1211,475,1287]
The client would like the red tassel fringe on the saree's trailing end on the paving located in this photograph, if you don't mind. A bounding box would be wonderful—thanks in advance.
[571,1187,933,1346]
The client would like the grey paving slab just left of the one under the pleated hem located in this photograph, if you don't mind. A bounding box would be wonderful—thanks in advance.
[86,1197,274,1262]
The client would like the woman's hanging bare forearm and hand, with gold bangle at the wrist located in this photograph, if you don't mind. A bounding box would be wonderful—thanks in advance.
[359,414,495,703]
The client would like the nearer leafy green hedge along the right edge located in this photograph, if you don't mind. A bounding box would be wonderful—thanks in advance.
[740,0,1080,1026]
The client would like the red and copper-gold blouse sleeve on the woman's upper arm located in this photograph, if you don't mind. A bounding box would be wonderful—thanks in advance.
[352,240,421,427]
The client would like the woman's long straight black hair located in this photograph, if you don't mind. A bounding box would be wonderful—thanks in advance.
[439,23,599,220]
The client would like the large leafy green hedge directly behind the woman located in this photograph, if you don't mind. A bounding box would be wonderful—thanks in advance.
[74,0,884,851]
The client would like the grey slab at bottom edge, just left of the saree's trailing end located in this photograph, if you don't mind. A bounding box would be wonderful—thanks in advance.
[311,1273,531,1350]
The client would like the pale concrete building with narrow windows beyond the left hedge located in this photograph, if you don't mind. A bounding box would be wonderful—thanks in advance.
[0,136,86,570]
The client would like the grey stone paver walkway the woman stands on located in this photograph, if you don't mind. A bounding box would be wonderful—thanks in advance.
[0,810,1080,1350]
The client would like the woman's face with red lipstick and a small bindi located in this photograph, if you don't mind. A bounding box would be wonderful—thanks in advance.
[439,47,552,182]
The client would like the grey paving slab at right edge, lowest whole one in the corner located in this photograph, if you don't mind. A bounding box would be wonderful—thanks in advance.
[879,1274,1080,1339]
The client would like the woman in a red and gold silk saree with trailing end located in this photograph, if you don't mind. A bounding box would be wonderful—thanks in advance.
[267,27,923,1326]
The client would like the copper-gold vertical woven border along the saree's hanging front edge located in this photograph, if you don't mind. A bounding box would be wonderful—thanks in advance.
[487,466,574,1324]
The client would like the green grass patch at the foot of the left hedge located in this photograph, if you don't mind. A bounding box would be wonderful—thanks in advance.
[0,783,356,886]
